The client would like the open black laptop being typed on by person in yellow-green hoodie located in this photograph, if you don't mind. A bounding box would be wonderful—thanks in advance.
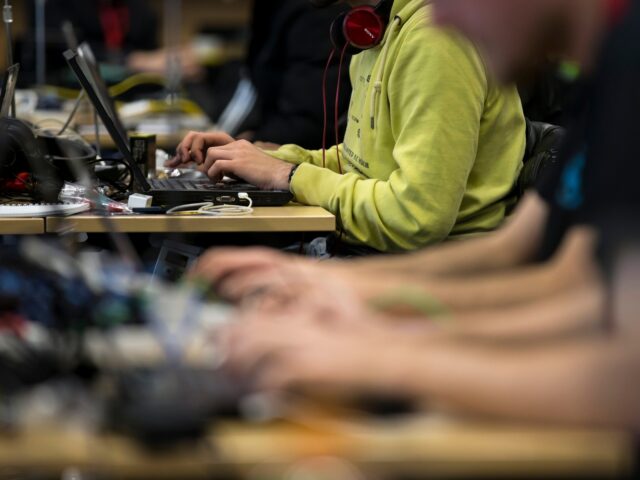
[64,50,293,207]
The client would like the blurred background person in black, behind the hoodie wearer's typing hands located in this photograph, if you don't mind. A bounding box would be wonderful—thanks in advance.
[127,0,351,139]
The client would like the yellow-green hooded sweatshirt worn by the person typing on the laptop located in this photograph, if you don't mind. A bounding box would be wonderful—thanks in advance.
[273,0,525,252]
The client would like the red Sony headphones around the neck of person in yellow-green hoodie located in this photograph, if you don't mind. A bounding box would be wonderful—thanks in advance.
[331,0,393,54]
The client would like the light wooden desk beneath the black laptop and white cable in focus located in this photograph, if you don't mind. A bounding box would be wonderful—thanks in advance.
[46,205,336,233]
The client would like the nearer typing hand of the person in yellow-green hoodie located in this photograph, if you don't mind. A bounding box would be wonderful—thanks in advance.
[199,140,294,190]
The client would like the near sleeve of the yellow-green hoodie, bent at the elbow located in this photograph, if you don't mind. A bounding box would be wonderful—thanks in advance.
[272,22,488,252]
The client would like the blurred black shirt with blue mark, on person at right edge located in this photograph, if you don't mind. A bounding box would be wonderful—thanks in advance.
[538,0,640,258]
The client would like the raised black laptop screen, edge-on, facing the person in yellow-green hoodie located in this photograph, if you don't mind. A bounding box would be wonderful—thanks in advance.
[64,50,150,191]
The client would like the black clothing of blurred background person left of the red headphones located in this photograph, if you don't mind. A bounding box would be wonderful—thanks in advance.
[240,0,351,149]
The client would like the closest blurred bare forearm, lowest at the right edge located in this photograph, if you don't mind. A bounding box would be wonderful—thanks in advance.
[378,338,640,428]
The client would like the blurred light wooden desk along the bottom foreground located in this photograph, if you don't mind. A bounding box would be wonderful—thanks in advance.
[0,419,633,480]
